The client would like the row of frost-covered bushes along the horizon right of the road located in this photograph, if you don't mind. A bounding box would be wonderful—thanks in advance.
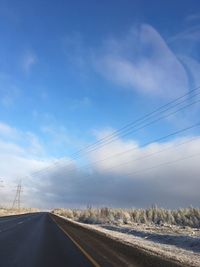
[53,206,200,228]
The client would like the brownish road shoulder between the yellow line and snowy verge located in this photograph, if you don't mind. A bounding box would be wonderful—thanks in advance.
[51,214,184,267]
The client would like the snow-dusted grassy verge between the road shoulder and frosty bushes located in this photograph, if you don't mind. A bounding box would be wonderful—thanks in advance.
[60,217,200,267]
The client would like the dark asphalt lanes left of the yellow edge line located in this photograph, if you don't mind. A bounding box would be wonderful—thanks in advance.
[0,213,93,267]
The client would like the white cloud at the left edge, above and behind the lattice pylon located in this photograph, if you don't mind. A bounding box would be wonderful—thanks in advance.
[0,122,66,206]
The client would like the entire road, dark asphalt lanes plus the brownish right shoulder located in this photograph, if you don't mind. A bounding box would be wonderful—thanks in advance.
[0,213,183,267]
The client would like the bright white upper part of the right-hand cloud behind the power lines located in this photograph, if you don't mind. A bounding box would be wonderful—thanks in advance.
[91,133,200,177]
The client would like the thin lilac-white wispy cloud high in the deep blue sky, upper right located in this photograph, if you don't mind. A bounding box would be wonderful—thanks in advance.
[61,23,200,99]
